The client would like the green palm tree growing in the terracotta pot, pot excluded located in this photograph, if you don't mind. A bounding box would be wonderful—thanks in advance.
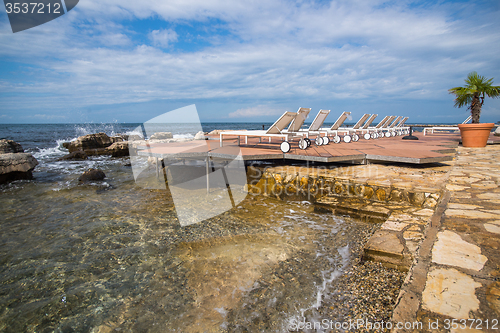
[448,72,500,124]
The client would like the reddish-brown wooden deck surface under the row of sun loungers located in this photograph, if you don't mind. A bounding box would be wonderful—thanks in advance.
[139,133,500,164]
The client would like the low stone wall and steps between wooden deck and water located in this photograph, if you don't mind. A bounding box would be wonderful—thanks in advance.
[247,166,449,271]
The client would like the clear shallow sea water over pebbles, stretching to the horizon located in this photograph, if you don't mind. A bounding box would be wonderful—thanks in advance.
[0,123,394,332]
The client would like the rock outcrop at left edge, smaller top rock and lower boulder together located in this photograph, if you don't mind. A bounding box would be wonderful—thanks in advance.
[0,139,38,184]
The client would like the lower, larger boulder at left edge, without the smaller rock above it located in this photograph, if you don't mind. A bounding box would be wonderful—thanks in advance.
[0,153,38,183]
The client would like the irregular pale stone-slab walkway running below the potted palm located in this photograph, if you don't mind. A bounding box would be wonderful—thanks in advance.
[393,145,500,332]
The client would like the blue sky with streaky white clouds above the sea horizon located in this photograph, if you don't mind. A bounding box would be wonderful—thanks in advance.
[0,0,500,123]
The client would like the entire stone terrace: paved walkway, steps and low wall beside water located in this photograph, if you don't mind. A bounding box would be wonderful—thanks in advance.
[249,145,500,332]
